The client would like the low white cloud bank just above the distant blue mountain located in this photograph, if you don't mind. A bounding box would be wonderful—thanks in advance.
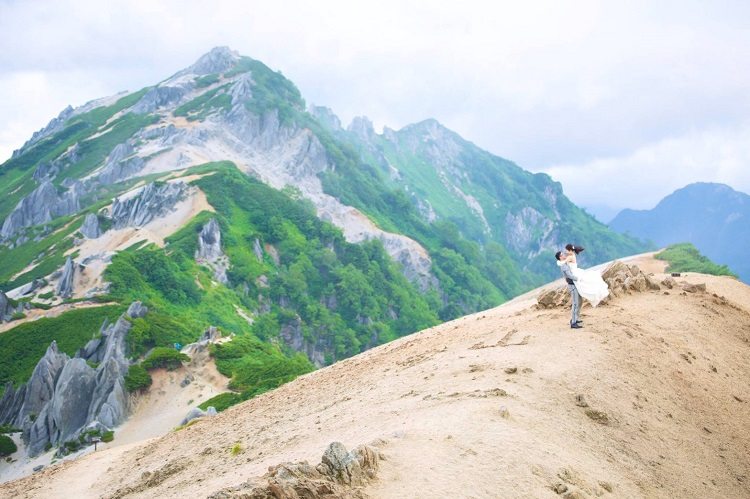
[543,123,750,213]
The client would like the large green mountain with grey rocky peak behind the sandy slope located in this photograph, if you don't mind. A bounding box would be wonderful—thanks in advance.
[0,48,646,405]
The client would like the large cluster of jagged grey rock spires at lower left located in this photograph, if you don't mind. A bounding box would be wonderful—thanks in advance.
[0,302,147,456]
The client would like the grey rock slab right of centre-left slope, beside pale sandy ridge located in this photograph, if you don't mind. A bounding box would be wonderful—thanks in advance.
[110,182,187,229]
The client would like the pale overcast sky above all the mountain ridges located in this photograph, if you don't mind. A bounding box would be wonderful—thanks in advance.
[0,0,750,220]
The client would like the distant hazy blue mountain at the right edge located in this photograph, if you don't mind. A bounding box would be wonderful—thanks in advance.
[609,183,750,282]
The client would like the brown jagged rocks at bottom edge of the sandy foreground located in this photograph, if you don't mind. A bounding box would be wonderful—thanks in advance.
[209,442,383,499]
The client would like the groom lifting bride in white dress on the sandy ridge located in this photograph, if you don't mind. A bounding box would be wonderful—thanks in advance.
[555,244,609,329]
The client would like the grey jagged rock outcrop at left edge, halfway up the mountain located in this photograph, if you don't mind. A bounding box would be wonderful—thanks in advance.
[0,179,80,240]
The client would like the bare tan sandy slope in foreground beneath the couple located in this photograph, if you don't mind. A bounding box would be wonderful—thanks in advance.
[0,256,750,498]
